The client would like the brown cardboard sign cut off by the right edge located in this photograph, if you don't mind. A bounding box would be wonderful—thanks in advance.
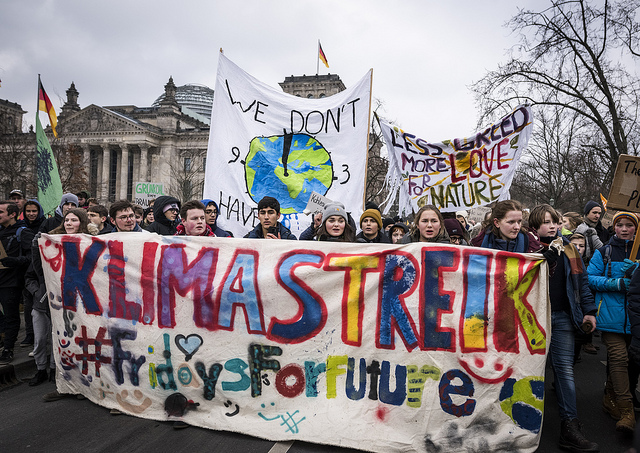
[607,154,640,212]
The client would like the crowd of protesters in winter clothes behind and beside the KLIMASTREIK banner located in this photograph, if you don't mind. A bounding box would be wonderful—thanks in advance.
[6,186,640,452]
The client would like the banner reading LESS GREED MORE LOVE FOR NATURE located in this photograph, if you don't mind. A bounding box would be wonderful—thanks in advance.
[381,105,533,214]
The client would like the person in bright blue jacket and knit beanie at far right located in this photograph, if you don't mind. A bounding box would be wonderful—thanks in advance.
[587,211,638,433]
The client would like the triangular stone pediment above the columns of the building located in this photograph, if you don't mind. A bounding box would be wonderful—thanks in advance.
[58,104,158,135]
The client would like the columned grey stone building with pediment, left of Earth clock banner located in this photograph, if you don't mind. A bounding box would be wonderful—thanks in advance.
[56,78,213,203]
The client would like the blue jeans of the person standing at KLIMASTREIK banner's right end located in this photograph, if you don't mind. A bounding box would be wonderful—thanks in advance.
[549,311,578,420]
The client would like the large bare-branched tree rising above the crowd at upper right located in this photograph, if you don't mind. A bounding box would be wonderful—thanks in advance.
[473,0,640,192]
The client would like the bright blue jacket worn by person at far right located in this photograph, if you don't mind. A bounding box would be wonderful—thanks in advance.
[587,236,633,333]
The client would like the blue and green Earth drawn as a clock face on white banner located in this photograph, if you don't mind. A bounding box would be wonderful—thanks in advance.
[244,134,333,214]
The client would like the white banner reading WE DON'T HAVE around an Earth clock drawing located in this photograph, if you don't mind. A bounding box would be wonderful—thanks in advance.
[204,54,372,236]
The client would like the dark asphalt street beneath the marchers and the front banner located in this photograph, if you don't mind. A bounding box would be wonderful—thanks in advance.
[0,324,640,453]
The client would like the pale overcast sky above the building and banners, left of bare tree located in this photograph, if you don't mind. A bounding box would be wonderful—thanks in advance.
[0,0,548,142]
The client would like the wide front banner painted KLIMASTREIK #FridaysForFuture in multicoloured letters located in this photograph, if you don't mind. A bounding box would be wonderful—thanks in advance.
[39,233,550,452]
